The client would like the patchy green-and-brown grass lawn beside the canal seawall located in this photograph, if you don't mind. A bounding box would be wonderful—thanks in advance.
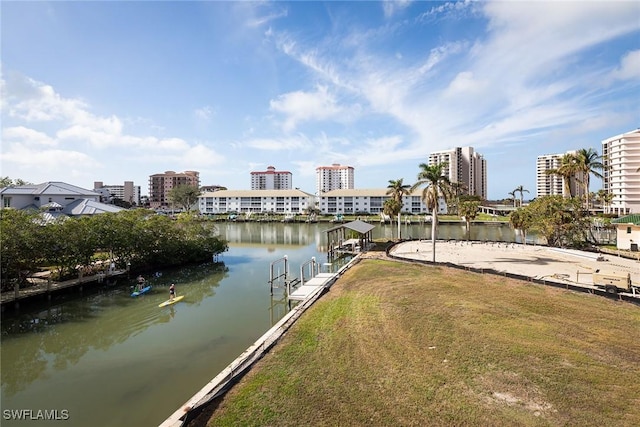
[204,260,640,426]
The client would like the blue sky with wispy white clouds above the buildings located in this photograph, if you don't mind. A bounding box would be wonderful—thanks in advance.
[0,1,640,199]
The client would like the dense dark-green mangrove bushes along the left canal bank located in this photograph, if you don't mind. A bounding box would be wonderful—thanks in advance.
[0,209,228,290]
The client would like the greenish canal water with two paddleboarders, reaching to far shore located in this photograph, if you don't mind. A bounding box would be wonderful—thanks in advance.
[0,223,536,427]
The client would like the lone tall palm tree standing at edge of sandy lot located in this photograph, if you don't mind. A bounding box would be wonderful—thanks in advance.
[410,163,451,262]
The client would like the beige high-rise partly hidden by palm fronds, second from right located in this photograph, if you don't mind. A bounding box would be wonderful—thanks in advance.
[536,150,584,197]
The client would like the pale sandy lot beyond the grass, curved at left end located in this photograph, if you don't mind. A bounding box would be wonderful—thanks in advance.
[390,240,640,285]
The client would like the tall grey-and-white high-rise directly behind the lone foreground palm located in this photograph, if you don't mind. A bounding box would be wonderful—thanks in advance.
[429,147,487,200]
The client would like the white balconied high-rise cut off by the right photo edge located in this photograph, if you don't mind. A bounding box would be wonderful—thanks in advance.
[602,129,640,215]
